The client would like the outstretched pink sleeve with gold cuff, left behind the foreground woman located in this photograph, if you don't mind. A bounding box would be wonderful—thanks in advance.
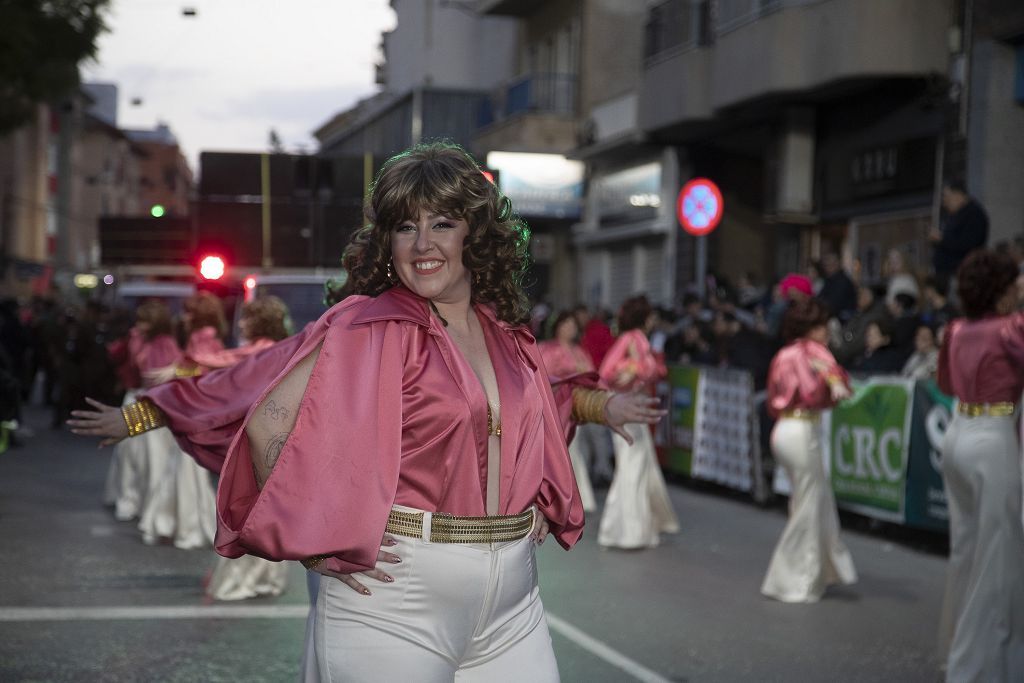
[142,323,313,473]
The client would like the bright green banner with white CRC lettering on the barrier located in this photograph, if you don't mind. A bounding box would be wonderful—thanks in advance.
[828,379,913,523]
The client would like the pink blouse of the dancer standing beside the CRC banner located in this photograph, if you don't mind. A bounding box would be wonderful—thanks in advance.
[766,339,850,418]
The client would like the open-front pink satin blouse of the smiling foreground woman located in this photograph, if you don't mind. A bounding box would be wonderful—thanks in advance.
[216,287,584,571]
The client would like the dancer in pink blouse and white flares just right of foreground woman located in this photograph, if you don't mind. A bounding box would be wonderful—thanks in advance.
[597,296,679,548]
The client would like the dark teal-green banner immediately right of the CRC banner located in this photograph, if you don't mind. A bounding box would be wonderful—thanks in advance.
[906,380,953,531]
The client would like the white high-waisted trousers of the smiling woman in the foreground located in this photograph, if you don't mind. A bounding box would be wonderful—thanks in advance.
[312,509,559,683]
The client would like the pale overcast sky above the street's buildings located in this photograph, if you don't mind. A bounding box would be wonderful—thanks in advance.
[83,0,395,170]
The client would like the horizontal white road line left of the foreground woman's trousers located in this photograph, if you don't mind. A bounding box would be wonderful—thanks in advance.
[0,604,309,622]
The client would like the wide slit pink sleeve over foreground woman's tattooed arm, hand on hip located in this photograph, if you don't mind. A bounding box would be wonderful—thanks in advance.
[215,297,403,572]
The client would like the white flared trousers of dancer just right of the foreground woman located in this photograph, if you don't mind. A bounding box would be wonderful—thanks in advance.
[597,424,679,549]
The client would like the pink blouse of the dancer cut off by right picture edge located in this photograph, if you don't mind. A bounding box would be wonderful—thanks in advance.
[938,312,1024,403]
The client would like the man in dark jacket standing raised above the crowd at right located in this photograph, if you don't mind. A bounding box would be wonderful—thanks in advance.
[929,179,988,283]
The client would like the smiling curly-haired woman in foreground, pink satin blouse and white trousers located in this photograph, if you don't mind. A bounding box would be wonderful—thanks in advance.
[217,144,622,681]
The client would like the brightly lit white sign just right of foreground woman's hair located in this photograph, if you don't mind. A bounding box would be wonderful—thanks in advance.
[487,152,584,218]
